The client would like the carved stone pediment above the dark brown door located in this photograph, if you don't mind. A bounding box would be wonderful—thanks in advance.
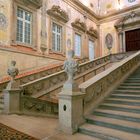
[115,11,140,30]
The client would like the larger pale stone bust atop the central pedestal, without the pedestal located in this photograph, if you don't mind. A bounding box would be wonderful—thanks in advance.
[63,50,78,83]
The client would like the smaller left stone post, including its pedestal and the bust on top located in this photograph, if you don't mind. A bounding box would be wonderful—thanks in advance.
[3,61,21,114]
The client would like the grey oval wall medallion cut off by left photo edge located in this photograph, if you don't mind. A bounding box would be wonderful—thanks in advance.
[0,13,7,30]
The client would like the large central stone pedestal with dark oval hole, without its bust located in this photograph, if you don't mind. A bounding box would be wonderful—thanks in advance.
[59,83,85,134]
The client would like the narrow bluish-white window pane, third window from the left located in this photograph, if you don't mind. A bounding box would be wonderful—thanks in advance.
[74,34,81,57]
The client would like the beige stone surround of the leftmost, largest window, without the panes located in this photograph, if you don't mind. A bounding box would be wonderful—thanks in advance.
[10,1,38,50]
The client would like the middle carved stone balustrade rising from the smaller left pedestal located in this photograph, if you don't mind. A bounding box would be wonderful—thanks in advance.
[21,55,110,97]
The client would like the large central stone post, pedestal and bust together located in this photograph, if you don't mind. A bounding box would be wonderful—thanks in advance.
[59,50,85,134]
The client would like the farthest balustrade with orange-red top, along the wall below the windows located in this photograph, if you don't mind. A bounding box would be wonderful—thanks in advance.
[0,58,88,91]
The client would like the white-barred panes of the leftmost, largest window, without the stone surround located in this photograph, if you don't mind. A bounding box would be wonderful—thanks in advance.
[17,8,32,44]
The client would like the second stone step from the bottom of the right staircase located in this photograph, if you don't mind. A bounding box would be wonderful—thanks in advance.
[86,115,140,135]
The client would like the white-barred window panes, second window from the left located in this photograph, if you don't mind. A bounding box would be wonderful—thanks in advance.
[52,23,62,52]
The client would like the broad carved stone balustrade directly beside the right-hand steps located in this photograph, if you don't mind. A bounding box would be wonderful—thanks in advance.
[79,51,140,114]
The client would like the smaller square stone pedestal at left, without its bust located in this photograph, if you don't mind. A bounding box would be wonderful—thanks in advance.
[3,89,21,114]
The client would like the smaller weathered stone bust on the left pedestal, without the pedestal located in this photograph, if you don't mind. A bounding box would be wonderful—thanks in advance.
[6,61,19,90]
